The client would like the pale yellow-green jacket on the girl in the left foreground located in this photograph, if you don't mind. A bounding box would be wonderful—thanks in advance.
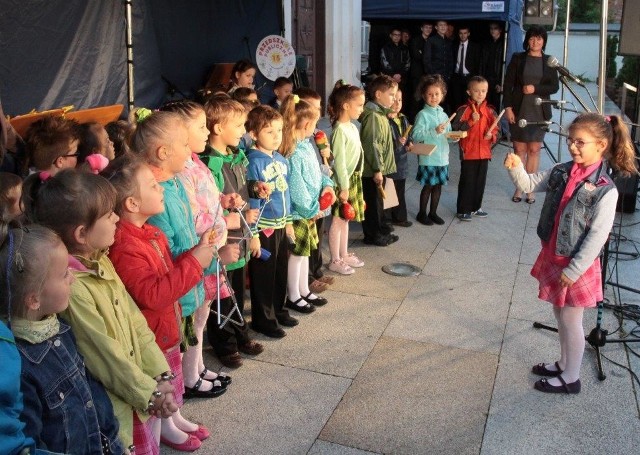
[61,254,169,446]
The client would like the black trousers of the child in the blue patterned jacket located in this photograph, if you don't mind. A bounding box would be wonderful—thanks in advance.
[249,228,289,331]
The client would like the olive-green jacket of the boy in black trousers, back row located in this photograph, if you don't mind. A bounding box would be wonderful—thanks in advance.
[360,101,396,177]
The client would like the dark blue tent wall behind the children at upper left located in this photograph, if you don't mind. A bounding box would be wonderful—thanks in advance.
[0,0,281,115]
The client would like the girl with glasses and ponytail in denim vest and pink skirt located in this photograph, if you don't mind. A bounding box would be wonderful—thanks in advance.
[505,113,638,393]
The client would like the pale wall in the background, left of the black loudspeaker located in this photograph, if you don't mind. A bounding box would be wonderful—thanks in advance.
[545,32,622,81]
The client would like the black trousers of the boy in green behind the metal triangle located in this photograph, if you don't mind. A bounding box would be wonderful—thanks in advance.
[207,267,249,356]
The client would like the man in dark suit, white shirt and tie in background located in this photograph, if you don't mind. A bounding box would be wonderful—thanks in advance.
[449,25,482,110]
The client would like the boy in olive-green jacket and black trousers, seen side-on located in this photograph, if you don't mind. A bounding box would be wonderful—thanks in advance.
[360,75,398,246]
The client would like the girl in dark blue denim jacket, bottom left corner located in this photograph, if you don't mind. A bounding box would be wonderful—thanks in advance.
[0,225,124,455]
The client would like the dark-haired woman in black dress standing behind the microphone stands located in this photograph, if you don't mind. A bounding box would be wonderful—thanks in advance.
[504,25,560,204]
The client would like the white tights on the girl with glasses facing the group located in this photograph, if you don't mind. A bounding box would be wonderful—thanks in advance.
[548,306,585,386]
